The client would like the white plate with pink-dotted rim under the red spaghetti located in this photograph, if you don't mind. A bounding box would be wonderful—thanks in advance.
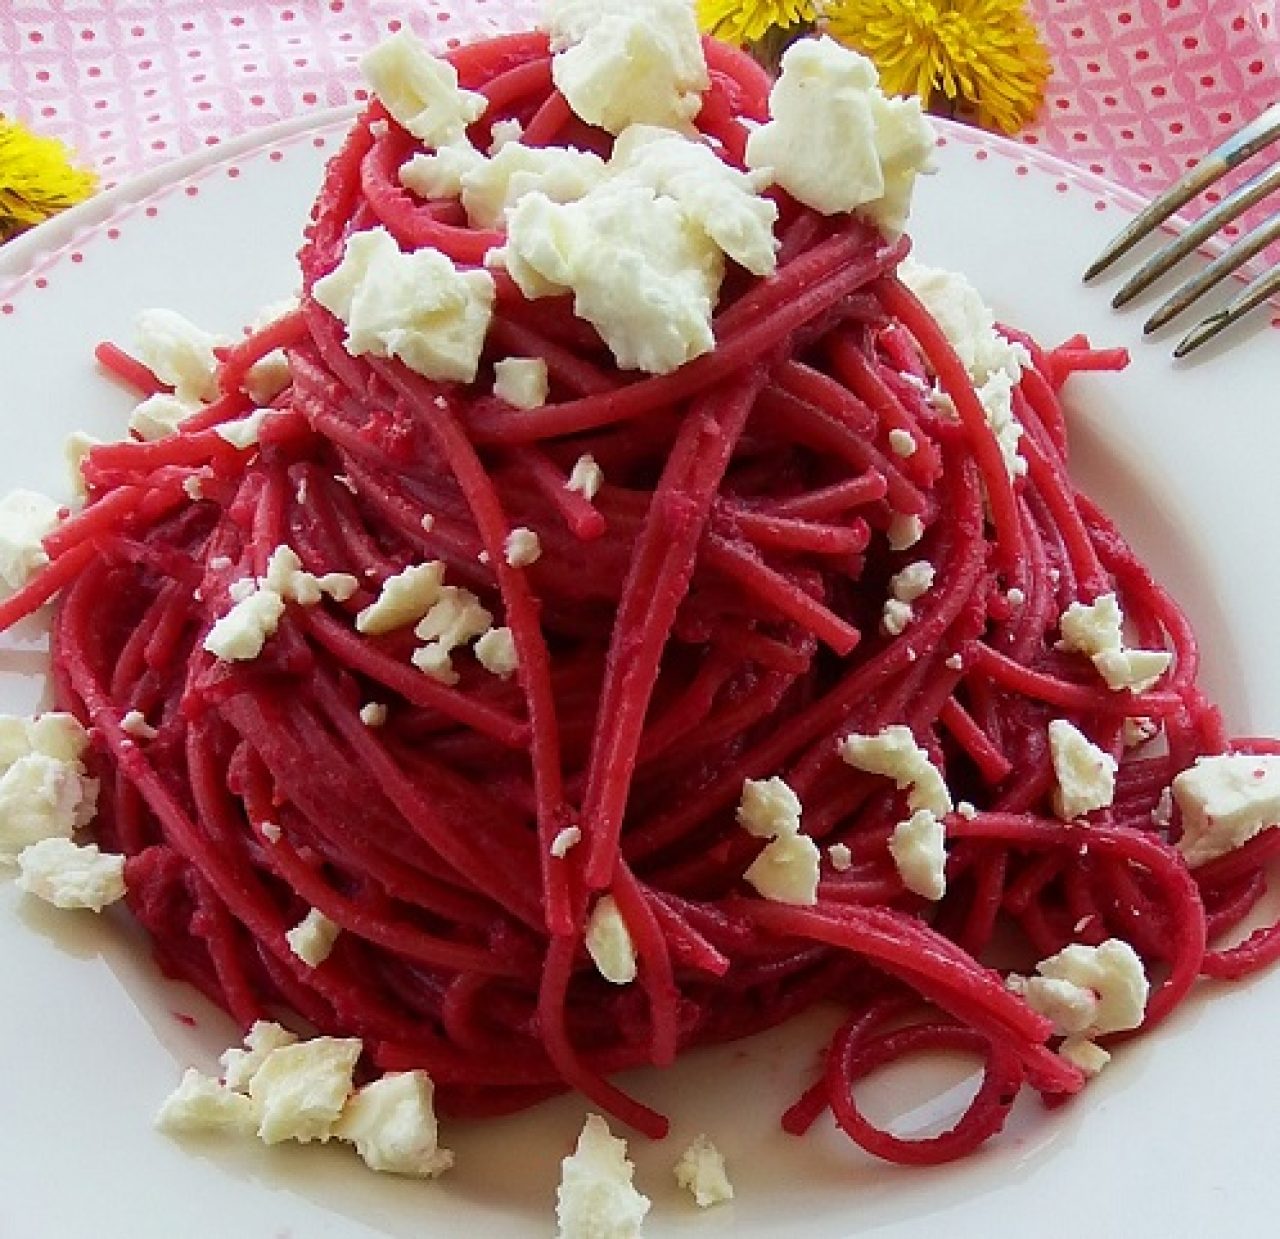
[0,116,1280,1239]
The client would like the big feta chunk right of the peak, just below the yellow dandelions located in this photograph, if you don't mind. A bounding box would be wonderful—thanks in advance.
[746,37,934,234]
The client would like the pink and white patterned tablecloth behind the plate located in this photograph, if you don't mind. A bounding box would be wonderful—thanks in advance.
[0,0,1280,216]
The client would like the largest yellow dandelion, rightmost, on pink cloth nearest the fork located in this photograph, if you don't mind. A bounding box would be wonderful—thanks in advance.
[827,0,1052,133]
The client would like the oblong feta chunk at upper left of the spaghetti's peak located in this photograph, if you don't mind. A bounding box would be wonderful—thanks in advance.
[360,29,488,146]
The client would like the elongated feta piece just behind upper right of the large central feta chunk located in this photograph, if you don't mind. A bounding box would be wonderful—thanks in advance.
[609,125,778,275]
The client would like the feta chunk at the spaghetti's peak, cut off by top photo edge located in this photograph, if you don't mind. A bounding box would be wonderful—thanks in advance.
[545,0,710,133]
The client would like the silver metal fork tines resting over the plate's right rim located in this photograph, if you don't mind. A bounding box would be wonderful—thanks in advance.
[1084,104,1280,357]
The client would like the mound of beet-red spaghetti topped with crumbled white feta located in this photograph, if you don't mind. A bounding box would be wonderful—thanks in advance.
[0,35,1280,1162]
